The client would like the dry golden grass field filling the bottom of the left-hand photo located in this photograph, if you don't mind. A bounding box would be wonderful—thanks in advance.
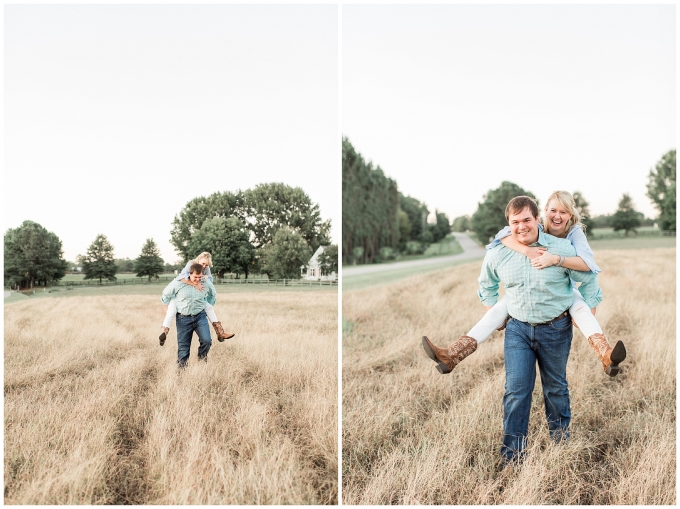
[4,288,338,505]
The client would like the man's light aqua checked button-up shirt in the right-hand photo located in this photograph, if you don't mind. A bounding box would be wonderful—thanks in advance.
[477,231,602,323]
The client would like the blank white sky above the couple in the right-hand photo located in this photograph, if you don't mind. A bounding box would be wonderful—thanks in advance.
[342,5,676,219]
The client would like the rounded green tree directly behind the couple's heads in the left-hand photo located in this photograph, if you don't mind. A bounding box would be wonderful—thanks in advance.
[188,217,255,279]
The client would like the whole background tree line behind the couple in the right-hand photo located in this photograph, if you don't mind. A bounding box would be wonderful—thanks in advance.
[342,143,676,263]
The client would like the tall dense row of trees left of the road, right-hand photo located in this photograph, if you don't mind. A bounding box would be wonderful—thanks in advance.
[342,137,451,263]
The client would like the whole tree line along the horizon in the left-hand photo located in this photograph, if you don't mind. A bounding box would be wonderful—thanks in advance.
[4,183,338,288]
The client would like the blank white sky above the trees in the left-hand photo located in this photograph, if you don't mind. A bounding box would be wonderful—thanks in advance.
[3,5,341,262]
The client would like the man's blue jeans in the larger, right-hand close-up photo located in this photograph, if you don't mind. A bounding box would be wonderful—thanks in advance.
[501,315,573,462]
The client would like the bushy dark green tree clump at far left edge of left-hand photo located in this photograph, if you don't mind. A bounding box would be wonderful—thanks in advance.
[4,221,67,288]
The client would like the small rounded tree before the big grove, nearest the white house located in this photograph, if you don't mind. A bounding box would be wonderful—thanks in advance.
[264,228,312,279]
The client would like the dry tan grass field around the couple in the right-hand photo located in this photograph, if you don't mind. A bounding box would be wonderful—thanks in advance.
[342,248,676,505]
